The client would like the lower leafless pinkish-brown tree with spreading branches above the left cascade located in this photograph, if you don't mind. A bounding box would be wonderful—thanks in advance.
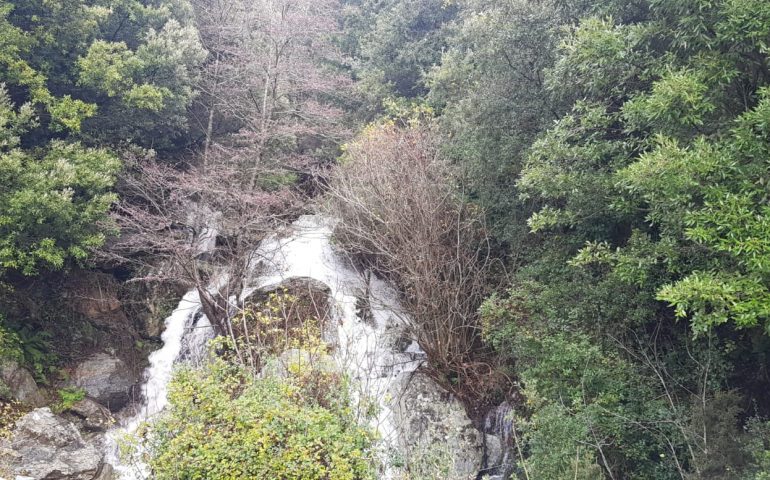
[101,148,297,333]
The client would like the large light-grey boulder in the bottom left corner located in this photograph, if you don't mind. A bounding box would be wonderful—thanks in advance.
[0,408,103,480]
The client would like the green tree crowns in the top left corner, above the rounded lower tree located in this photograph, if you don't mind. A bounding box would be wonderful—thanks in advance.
[0,0,206,146]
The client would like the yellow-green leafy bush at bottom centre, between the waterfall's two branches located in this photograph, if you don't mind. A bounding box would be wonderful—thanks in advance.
[142,360,373,480]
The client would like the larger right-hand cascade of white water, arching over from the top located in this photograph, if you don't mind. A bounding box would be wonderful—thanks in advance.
[246,215,422,479]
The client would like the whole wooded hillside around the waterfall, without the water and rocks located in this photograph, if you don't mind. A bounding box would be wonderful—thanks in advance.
[0,0,770,480]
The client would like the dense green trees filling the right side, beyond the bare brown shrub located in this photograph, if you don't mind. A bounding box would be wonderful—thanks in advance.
[352,0,770,479]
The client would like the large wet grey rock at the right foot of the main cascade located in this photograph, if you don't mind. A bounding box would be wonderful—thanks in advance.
[394,372,484,480]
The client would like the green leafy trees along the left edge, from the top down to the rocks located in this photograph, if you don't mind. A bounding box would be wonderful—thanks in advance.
[0,0,206,383]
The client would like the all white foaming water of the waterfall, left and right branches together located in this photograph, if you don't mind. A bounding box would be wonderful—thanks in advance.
[108,216,422,480]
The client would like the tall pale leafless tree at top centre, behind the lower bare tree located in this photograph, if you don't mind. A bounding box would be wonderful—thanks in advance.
[189,0,351,182]
